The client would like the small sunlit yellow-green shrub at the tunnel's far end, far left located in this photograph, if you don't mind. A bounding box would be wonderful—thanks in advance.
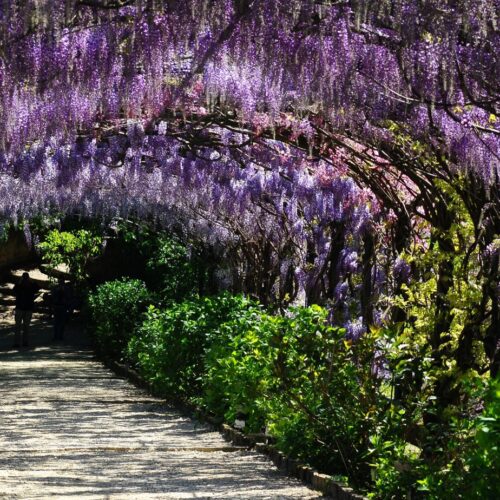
[38,229,103,281]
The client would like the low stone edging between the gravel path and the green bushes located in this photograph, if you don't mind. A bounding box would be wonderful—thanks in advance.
[101,356,368,500]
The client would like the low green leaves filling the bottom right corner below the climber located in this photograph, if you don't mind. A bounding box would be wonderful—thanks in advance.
[369,364,500,500]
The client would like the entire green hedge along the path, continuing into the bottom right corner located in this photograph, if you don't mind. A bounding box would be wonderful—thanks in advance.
[90,280,500,500]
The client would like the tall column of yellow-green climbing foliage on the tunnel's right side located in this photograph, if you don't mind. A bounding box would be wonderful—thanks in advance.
[369,181,492,499]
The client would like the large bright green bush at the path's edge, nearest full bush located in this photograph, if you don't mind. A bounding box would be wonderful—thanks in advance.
[203,306,377,480]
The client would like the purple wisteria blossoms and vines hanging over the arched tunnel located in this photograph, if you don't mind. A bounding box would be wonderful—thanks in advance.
[0,0,500,370]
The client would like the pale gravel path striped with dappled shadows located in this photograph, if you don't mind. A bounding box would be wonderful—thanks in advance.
[0,272,320,499]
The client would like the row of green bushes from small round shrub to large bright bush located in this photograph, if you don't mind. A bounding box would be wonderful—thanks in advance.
[90,280,375,486]
